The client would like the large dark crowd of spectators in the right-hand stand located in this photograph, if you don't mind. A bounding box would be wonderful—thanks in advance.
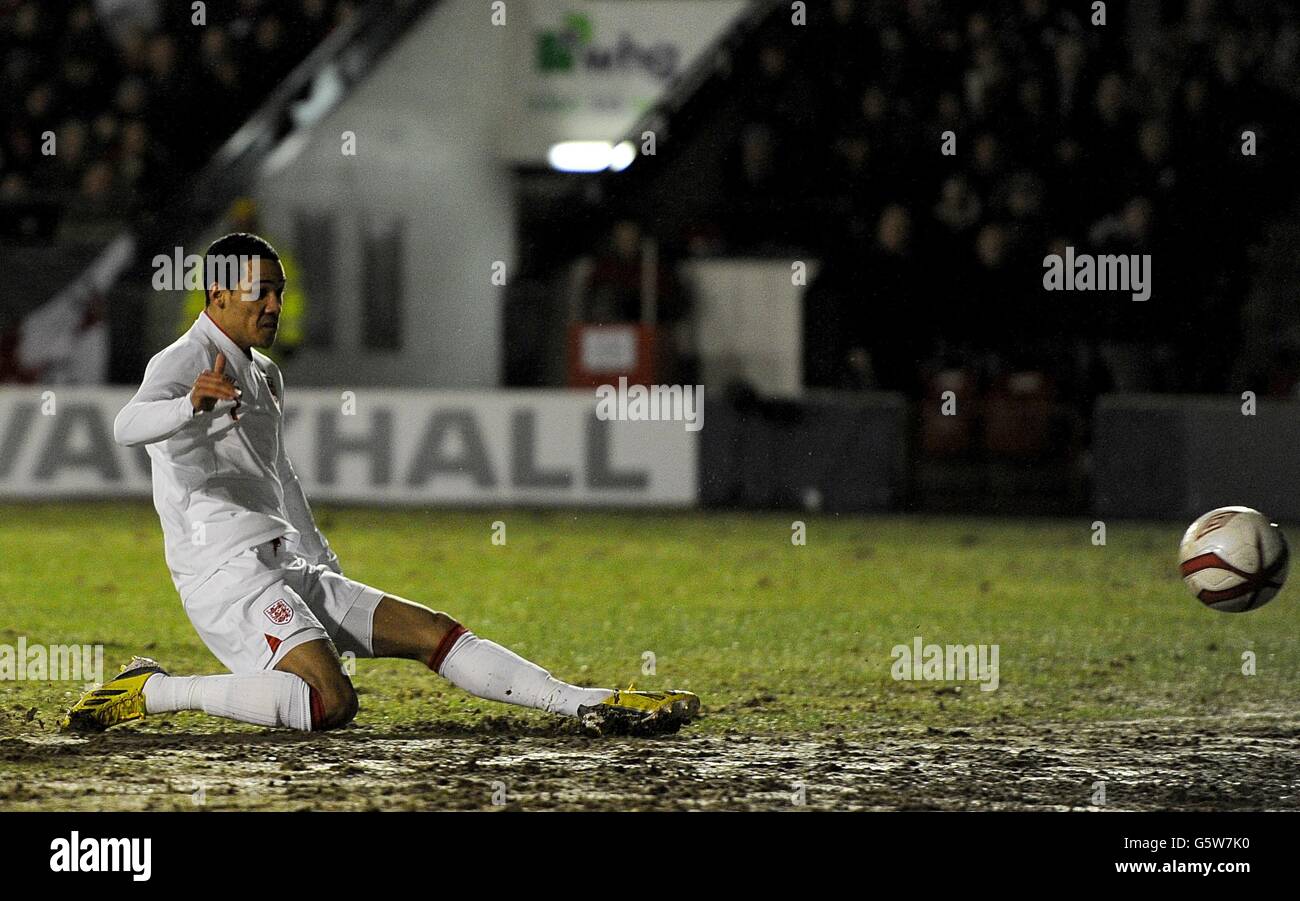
[716,0,1300,400]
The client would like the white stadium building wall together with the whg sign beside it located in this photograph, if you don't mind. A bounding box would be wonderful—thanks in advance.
[231,0,748,389]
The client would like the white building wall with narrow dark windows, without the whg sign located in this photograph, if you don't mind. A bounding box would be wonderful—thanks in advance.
[254,0,516,389]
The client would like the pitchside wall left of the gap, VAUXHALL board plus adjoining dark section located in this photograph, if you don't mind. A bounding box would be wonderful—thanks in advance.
[0,386,910,512]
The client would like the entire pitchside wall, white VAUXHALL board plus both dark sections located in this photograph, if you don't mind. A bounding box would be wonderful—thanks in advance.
[12,386,1279,520]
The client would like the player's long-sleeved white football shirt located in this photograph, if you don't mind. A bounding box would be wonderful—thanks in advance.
[113,311,338,598]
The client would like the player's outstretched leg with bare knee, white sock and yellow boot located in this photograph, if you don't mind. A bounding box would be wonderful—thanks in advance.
[372,595,699,733]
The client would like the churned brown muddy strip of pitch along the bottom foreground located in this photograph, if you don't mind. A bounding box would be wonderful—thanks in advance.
[0,716,1300,811]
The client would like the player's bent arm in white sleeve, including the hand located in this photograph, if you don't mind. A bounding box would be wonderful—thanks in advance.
[113,350,239,447]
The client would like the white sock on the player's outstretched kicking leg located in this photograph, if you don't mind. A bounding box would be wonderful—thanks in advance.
[438,632,614,716]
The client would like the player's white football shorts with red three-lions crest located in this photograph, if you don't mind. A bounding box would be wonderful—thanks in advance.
[182,538,384,672]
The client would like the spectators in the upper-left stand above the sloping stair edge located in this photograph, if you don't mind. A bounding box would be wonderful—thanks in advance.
[0,0,355,241]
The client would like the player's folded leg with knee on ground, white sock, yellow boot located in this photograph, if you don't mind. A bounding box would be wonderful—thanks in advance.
[62,641,356,732]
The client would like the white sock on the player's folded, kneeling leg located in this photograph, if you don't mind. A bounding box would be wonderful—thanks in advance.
[144,670,312,732]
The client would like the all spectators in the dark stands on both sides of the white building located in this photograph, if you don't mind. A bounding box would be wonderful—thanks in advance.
[10,0,1300,408]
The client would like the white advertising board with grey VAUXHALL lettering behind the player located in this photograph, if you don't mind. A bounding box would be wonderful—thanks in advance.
[0,387,698,507]
